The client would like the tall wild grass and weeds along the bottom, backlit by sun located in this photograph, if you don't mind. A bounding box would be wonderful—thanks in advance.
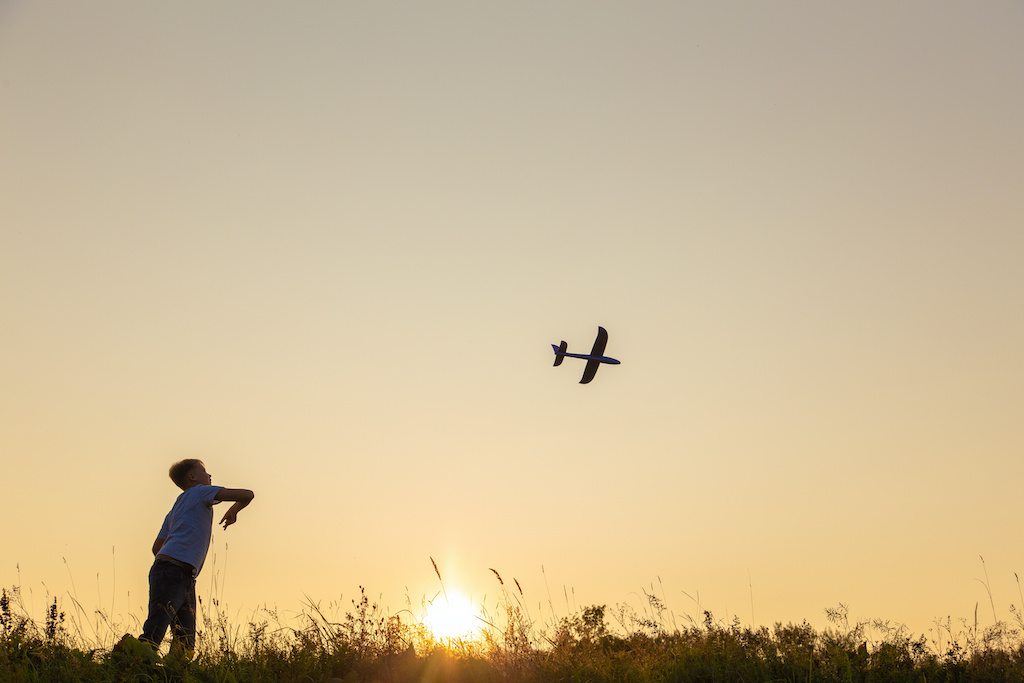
[6,560,1024,683]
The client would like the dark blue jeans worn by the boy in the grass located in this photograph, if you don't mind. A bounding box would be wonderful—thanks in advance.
[138,560,196,651]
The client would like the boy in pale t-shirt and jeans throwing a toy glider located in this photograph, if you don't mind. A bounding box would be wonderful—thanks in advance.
[128,459,253,659]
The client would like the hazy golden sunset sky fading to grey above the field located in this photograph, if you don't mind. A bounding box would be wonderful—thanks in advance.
[0,0,1024,634]
